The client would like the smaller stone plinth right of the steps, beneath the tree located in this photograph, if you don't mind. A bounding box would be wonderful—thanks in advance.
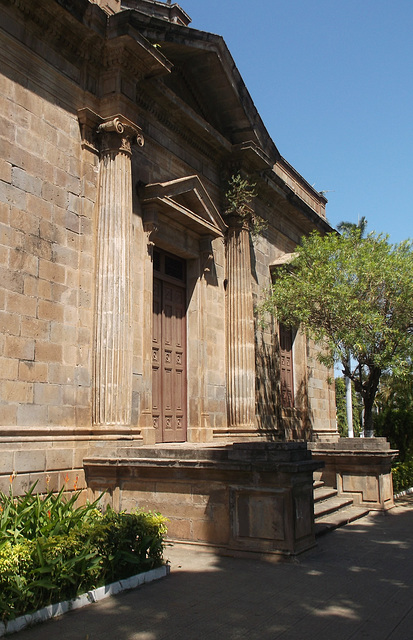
[309,438,397,510]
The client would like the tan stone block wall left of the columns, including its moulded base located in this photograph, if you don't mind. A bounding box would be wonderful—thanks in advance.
[0,10,97,496]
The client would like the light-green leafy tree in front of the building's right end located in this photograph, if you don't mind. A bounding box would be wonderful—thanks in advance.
[263,229,413,435]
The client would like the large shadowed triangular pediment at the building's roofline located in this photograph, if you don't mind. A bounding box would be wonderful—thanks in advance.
[125,11,280,164]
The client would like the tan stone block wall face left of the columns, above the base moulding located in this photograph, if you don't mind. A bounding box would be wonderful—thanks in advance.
[0,72,95,427]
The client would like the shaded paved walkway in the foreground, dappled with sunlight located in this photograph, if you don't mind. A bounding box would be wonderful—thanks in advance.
[13,496,413,640]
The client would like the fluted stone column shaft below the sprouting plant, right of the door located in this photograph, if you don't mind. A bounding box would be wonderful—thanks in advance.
[227,216,255,431]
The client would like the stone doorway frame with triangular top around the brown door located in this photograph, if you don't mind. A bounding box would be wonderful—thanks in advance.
[139,176,226,444]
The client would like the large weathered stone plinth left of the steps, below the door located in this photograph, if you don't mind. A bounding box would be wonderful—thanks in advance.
[84,443,320,555]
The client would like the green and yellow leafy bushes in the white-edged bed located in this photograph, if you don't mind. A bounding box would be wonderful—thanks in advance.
[0,485,166,621]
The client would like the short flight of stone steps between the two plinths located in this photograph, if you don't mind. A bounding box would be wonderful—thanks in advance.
[314,481,369,536]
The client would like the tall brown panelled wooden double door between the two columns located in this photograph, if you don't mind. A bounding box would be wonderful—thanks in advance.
[152,249,187,442]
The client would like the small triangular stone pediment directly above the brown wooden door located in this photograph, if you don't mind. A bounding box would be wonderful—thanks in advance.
[141,175,226,237]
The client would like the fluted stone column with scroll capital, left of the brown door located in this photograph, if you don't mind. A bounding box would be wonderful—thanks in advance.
[93,115,143,425]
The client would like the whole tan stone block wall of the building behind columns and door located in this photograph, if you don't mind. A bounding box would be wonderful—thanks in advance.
[0,0,331,500]
